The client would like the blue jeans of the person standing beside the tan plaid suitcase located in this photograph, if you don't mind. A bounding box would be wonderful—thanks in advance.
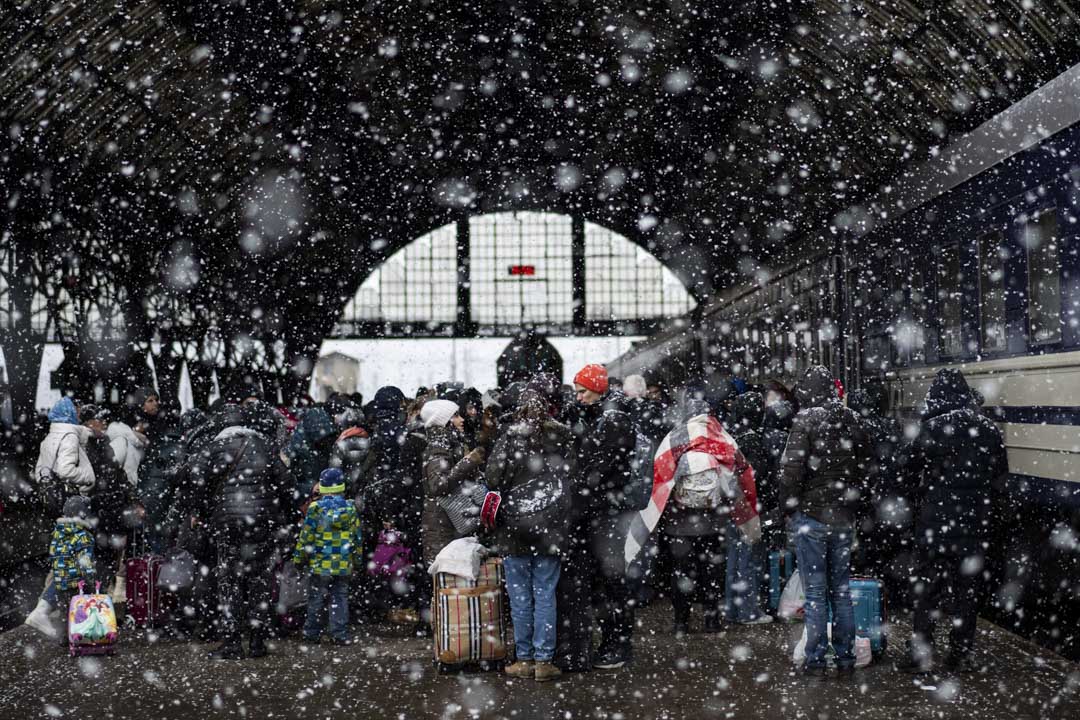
[502,555,561,663]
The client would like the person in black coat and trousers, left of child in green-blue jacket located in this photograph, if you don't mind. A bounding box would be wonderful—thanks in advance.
[183,405,294,660]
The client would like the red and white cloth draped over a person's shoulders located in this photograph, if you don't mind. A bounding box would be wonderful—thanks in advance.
[623,415,760,568]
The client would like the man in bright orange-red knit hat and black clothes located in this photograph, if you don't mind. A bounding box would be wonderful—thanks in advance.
[556,365,636,670]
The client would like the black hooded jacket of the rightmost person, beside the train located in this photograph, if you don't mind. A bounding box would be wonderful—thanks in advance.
[901,368,1009,544]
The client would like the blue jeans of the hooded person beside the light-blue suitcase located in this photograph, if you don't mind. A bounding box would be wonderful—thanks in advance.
[787,513,855,668]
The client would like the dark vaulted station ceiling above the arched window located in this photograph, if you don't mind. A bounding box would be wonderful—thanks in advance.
[0,0,1080,349]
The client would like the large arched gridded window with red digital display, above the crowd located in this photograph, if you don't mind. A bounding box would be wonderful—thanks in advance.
[338,212,696,335]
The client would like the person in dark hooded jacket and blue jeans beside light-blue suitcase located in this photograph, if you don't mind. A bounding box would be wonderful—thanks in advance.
[780,365,873,675]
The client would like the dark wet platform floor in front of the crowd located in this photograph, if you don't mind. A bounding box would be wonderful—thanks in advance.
[0,604,1080,720]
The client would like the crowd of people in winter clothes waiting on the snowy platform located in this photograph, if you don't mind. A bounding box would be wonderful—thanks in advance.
[27,365,1008,680]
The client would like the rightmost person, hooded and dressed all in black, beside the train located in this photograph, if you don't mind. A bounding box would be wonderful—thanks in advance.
[900,368,1009,673]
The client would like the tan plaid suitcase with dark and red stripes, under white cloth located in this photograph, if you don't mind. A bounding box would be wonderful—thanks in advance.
[432,558,507,670]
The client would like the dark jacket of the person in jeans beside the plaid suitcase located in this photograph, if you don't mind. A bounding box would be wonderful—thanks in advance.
[486,391,577,556]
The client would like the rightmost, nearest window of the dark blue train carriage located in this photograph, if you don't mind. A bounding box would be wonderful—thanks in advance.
[1021,210,1062,344]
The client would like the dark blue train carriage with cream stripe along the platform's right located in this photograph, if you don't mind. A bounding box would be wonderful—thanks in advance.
[612,66,1080,655]
